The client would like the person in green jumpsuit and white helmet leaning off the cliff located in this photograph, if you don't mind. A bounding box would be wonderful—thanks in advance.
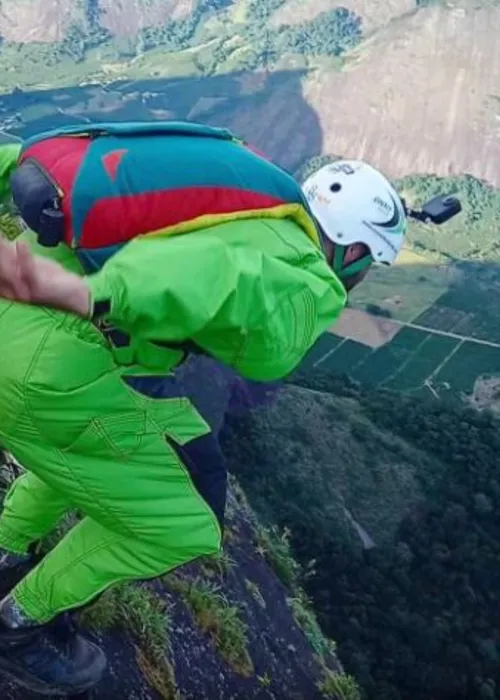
[0,138,406,694]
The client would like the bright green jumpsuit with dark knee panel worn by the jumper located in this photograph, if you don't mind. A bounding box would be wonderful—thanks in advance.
[0,146,346,623]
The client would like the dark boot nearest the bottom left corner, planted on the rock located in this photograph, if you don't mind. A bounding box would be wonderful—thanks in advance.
[0,598,106,695]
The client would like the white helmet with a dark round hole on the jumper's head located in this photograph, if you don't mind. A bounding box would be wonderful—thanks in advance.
[302,160,407,275]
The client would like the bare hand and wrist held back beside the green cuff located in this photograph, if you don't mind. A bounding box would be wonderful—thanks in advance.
[0,236,90,317]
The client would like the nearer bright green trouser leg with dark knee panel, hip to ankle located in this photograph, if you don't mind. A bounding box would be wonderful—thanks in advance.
[0,305,226,623]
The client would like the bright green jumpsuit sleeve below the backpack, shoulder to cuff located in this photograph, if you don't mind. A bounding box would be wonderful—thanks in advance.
[87,232,345,381]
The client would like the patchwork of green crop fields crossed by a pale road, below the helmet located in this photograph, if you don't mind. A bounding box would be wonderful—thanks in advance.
[305,241,500,398]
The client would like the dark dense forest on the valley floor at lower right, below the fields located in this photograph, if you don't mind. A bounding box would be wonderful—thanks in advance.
[224,375,500,700]
